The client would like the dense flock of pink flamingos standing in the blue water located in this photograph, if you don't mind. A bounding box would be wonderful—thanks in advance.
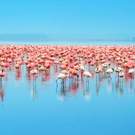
[0,45,135,100]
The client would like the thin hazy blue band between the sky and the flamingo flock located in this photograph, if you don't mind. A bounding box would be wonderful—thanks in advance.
[0,34,135,45]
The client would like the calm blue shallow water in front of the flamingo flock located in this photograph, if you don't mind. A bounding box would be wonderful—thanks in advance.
[0,64,135,135]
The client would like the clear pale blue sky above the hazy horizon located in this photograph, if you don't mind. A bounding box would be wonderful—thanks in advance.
[0,0,135,38]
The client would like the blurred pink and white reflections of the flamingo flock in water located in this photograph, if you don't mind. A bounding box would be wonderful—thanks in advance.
[0,65,135,101]
